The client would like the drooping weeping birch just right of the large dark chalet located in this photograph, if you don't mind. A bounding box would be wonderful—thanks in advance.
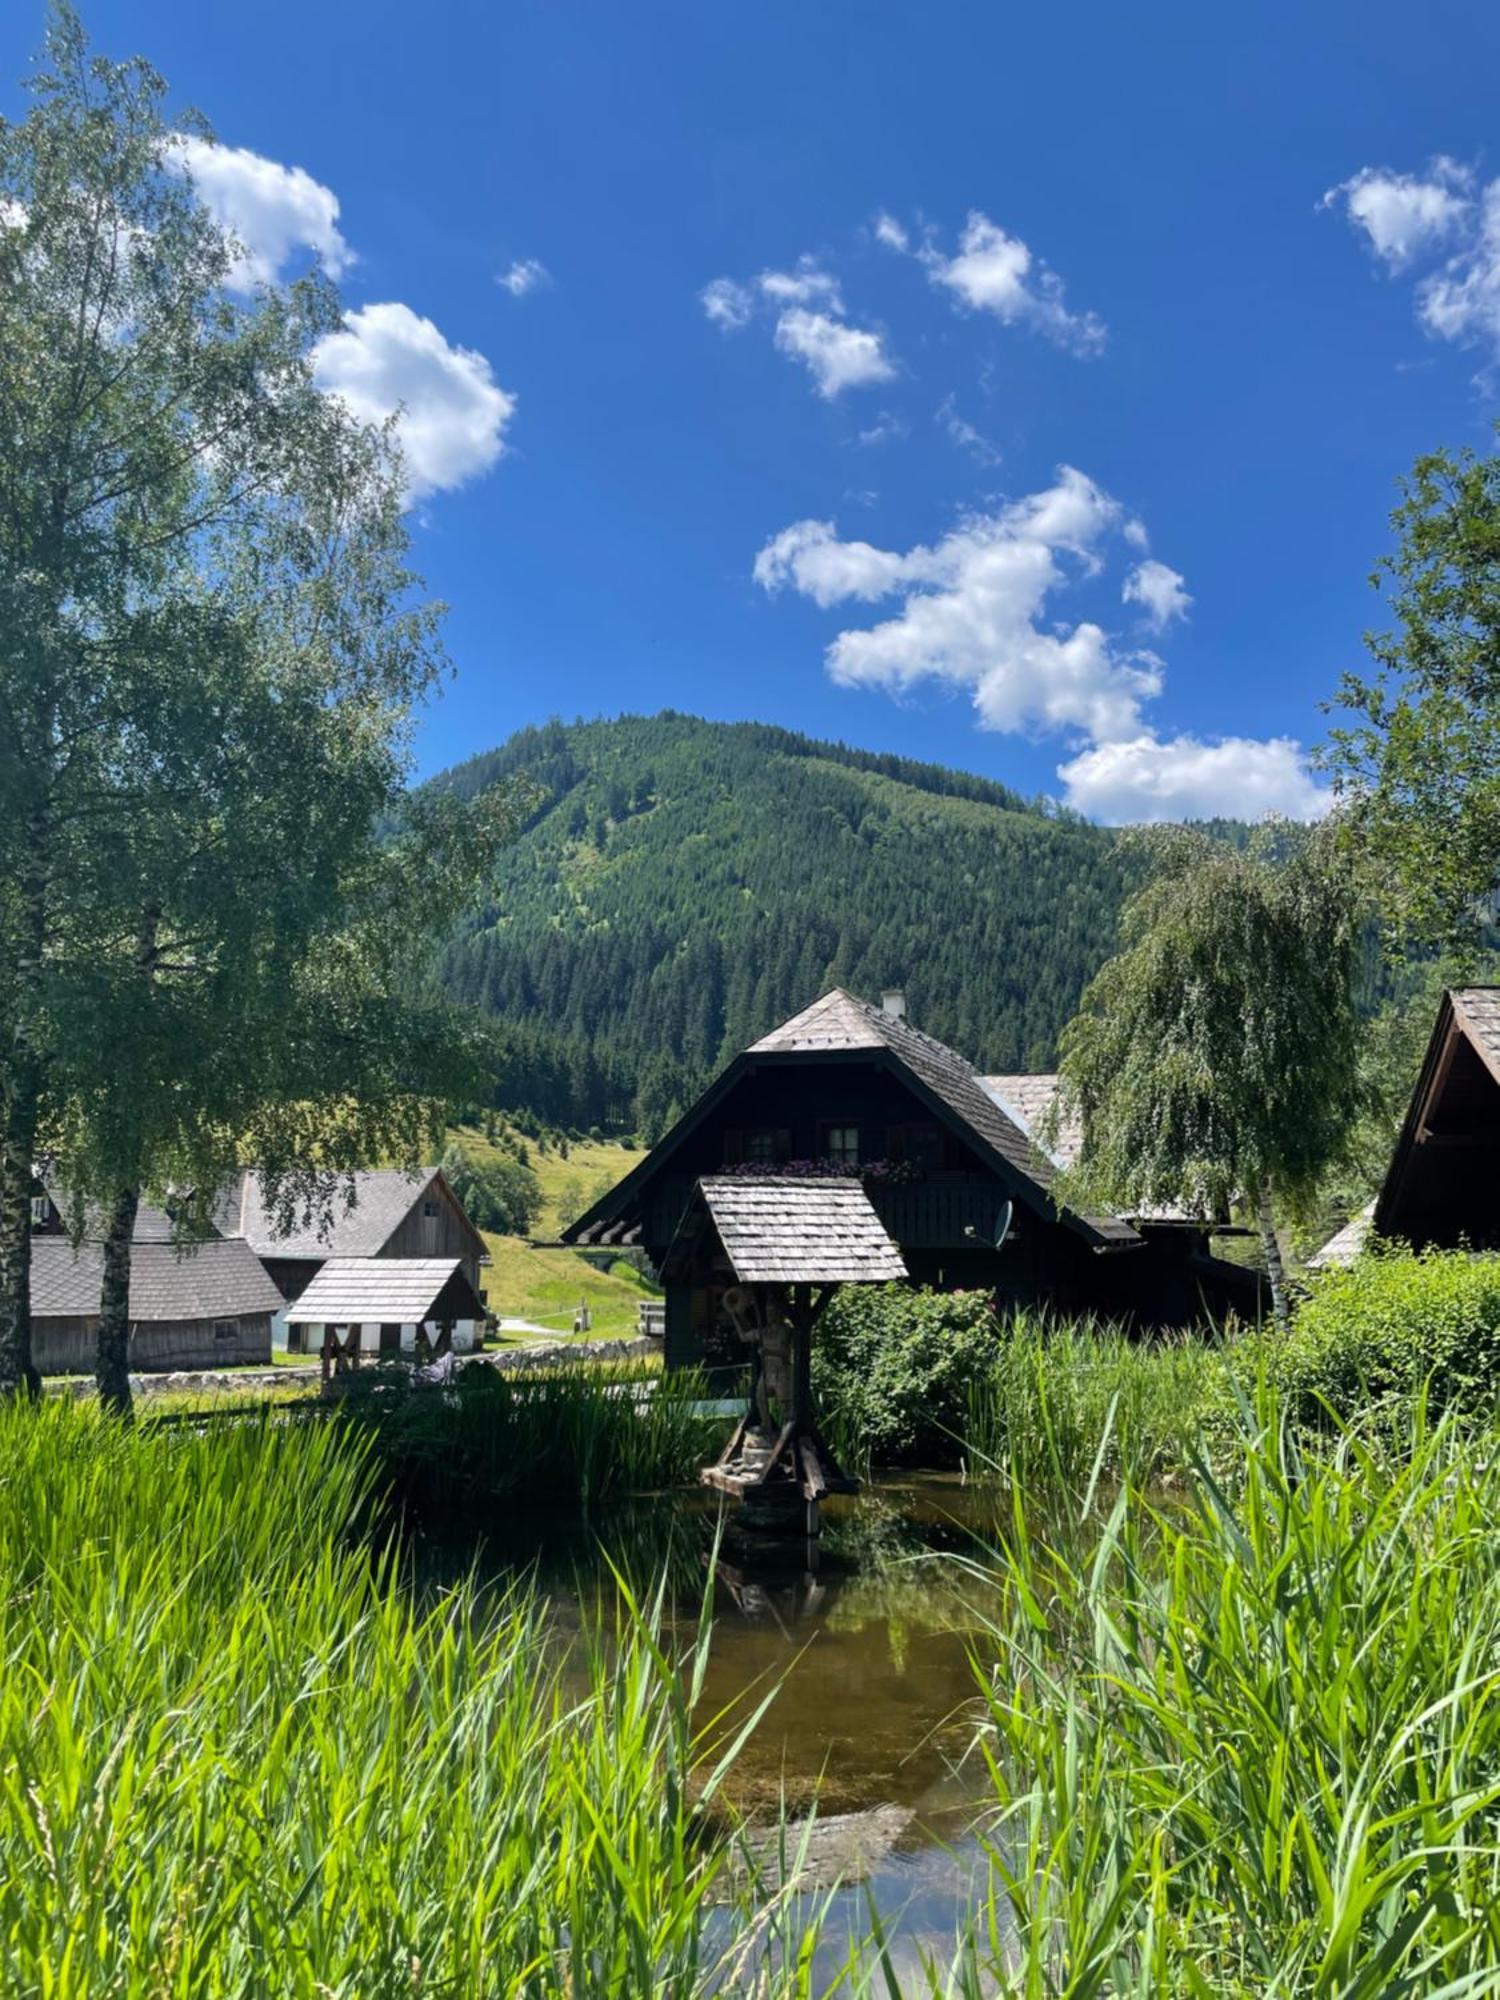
[1060,826,1368,1328]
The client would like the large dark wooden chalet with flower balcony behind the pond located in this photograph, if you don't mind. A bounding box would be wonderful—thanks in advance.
[564,988,1260,1366]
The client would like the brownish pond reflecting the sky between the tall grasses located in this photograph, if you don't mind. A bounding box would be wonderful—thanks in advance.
[424,1474,1012,1976]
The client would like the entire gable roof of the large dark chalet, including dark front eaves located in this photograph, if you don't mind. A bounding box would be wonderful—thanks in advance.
[564,986,1142,1250]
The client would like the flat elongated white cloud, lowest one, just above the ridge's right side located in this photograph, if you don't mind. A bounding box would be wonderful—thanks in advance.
[1058,730,1332,826]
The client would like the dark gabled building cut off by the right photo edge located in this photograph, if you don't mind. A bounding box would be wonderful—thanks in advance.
[1310,986,1500,1270]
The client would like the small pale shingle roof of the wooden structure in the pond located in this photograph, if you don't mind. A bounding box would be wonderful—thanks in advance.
[698,1174,908,1284]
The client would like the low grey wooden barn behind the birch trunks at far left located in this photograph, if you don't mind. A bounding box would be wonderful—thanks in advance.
[32,1192,282,1374]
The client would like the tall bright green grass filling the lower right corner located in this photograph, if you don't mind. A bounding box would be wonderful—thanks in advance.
[960,1404,1500,2000]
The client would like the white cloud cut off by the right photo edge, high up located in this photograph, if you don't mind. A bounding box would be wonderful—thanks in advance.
[1320,154,1500,360]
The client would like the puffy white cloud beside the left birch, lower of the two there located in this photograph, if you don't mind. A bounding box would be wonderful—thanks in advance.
[312,304,516,500]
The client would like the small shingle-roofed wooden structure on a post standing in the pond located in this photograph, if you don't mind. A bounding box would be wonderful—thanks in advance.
[664,1174,908,1534]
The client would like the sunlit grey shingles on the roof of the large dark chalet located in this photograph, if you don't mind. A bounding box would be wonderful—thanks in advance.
[750,986,1140,1248]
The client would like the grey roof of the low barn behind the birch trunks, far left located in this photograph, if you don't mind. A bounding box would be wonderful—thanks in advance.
[32,1236,282,1322]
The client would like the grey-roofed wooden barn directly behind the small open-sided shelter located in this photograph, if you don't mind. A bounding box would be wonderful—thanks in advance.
[214,1166,488,1354]
